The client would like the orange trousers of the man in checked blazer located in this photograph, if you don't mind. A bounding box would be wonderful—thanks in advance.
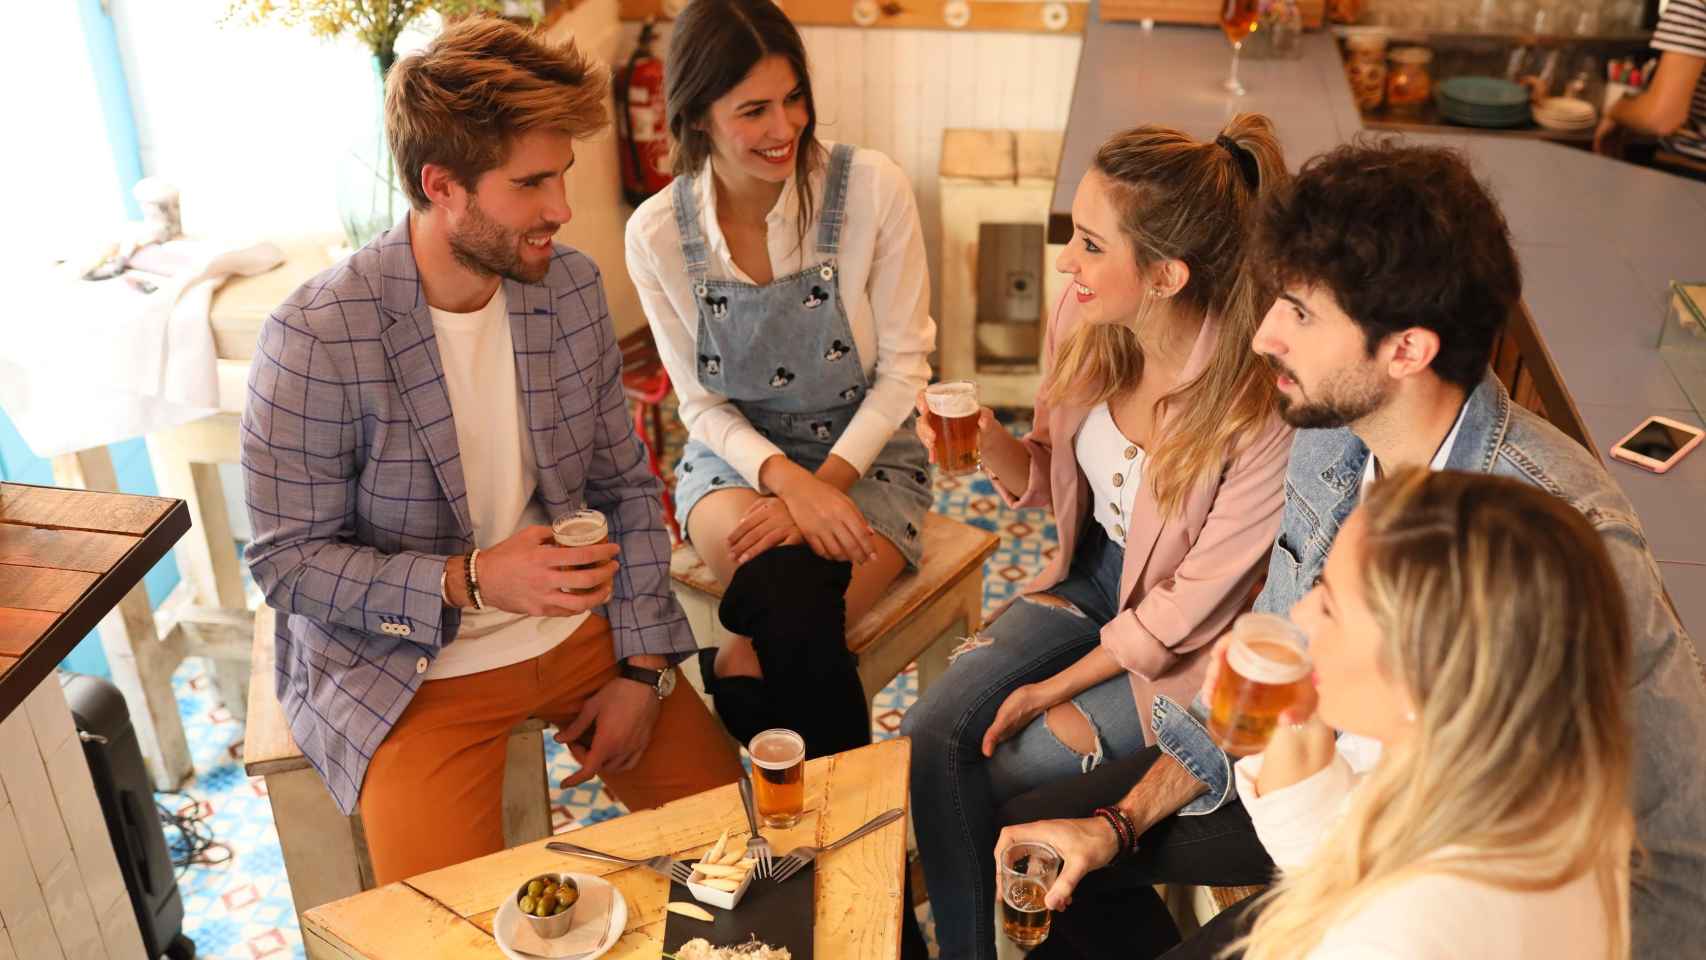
[360,616,740,883]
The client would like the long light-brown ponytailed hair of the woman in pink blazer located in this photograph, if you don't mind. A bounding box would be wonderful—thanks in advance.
[1042,113,1286,517]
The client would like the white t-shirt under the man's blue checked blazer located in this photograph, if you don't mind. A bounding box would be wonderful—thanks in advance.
[425,285,587,680]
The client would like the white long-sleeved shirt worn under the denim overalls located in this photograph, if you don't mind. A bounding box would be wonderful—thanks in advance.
[626,142,937,489]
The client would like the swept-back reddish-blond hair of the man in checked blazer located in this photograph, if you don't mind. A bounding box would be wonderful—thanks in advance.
[386,17,609,211]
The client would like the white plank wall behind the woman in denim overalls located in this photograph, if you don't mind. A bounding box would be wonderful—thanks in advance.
[619,22,1083,314]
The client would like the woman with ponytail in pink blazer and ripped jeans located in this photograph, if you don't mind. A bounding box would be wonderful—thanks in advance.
[901,114,1291,960]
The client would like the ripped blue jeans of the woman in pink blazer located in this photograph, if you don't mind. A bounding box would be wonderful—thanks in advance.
[901,523,1146,960]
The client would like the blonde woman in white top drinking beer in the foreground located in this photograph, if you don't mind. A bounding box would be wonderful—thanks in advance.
[1169,469,1633,960]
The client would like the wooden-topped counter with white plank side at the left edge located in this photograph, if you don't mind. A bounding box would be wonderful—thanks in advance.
[0,483,189,958]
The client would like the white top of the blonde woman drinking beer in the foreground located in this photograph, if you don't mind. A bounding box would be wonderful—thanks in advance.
[1233,754,1612,960]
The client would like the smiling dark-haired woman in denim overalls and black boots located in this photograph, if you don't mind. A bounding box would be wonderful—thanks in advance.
[628,0,935,755]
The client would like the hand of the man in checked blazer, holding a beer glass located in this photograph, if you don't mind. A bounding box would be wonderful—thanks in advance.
[478,527,621,617]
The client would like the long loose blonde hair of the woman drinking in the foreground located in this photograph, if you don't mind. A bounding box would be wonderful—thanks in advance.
[1239,469,1634,960]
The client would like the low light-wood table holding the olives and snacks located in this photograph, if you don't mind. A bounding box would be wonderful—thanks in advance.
[302,738,911,960]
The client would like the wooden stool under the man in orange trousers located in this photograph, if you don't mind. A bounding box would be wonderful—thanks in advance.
[242,607,551,916]
